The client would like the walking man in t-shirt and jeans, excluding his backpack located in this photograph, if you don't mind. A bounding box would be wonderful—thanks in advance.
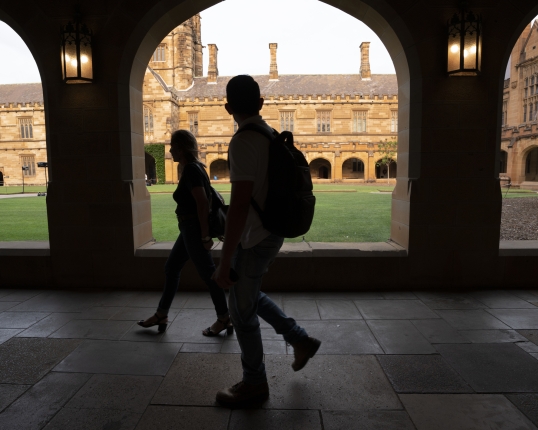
[214,75,321,408]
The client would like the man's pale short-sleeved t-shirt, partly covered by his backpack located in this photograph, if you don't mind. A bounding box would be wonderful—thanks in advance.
[229,115,273,248]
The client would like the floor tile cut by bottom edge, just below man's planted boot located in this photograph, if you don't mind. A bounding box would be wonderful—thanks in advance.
[230,409,320,430]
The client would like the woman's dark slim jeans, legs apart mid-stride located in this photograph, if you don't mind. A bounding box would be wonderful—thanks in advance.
[157,219,228,317]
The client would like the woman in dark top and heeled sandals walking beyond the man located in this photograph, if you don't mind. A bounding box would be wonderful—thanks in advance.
[138,130,233,336]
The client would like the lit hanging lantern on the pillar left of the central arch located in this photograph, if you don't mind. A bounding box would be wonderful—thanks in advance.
[60,13,93,84]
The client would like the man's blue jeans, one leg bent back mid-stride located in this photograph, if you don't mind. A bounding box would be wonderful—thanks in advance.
[229,234,308,384]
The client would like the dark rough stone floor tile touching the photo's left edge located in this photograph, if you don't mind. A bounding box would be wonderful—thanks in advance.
[0,337,81,384]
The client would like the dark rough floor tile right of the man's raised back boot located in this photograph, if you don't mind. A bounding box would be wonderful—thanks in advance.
[377,355,473,393]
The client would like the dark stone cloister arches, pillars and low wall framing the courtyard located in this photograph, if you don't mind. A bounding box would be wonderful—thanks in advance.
[0,0,538,290]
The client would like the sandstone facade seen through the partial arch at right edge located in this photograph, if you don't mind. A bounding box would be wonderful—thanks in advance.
[499,21,538,191]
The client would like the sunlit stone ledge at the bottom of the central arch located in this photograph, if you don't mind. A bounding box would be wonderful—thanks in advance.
[135,242,407,258]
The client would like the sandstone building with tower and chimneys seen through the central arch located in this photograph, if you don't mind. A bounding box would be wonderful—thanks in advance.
[143,15,398,183]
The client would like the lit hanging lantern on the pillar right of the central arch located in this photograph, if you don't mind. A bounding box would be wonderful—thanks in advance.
[447,2,482,76]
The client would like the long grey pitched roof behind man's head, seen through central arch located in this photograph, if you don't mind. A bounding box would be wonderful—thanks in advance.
[172,75,398,100]
